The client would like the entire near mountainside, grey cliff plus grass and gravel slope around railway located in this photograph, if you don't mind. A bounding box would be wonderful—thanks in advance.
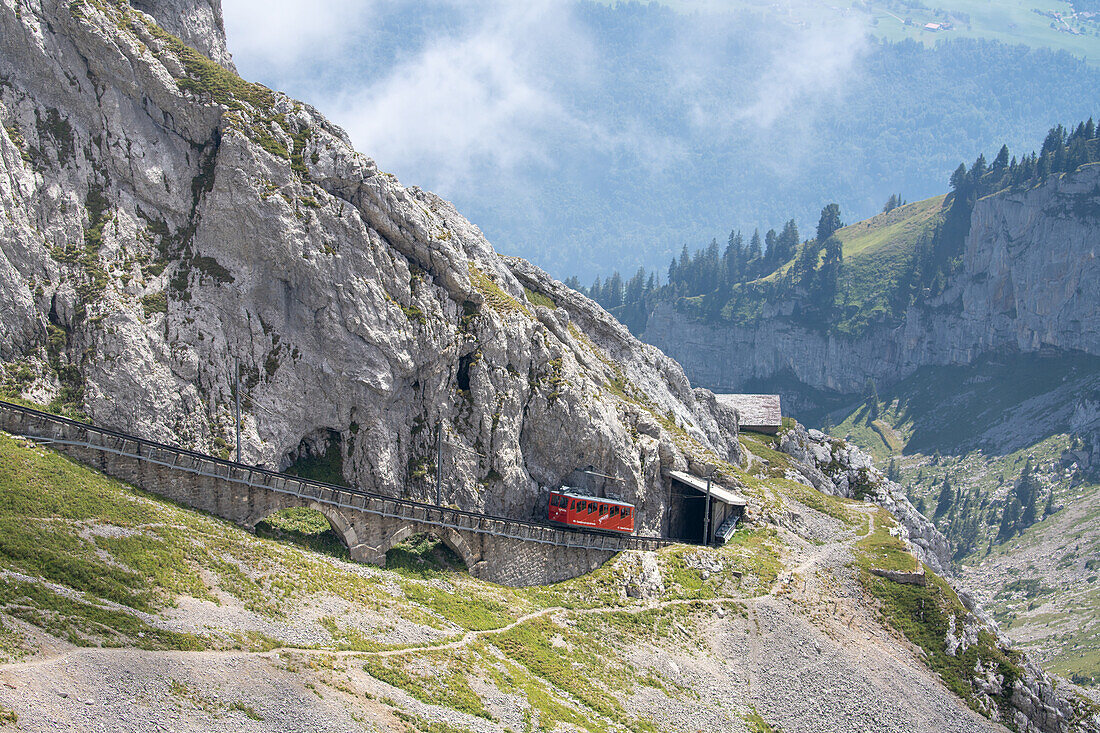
[0,0,1097,733]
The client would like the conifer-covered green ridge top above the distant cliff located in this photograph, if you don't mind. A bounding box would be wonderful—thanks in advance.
[569,118,1100,336]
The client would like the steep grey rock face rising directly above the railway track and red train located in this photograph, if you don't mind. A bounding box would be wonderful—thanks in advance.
[0,0,739,533]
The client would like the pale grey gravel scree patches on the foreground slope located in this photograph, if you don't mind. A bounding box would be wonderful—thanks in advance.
[0,507,1020,733]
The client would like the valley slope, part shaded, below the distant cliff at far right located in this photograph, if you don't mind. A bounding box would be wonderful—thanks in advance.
[831,355,1100,681]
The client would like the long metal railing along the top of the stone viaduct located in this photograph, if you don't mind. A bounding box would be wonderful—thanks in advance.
[0,400,674,551]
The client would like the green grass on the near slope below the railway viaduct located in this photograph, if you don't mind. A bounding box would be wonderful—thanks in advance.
[0,424,1029,733]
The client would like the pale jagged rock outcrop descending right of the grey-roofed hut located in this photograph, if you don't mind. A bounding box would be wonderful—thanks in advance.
[780,423,952,573]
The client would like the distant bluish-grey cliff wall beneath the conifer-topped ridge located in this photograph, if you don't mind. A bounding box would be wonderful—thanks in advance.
[644,164,1100,393]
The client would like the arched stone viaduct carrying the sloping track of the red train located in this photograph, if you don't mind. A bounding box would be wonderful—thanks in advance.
[0,401,671,586]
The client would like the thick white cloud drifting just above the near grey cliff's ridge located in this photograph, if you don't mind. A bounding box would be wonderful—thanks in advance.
[325,0,608,192]
